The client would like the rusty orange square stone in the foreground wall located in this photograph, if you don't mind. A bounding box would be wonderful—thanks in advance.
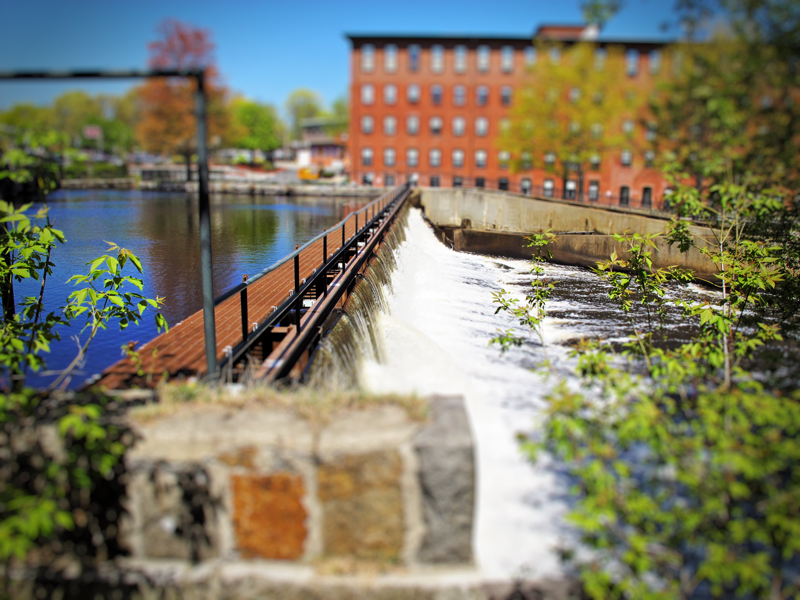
[231,473,307,560]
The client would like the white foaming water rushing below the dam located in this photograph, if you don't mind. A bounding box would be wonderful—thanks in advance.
[360,209,592,578]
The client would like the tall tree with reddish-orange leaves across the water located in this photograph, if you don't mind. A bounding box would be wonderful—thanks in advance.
[136,19,229,180]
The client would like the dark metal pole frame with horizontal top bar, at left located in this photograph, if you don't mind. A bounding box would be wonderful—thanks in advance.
[0,68,219,379]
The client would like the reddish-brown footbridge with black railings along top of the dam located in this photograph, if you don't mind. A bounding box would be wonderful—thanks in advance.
[96,184,411,389]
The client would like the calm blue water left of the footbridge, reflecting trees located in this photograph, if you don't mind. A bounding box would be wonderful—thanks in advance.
[15,190,365,387]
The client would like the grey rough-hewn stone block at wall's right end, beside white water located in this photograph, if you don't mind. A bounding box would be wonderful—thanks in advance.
[414,397,475,564]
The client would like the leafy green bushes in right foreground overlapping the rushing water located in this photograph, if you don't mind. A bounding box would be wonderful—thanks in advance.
[501,172,800,600]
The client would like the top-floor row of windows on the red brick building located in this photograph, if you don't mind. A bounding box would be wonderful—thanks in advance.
[361,44,661,77]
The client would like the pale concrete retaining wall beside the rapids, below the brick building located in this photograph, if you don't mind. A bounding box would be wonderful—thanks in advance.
[415,188,716,279]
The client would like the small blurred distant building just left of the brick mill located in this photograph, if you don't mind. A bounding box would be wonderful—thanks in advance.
[297,117,350,174]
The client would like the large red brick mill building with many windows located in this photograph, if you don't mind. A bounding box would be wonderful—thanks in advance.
[347,25,667,208]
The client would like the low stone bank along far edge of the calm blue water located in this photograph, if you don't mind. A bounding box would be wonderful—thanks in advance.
[61,177,384,197]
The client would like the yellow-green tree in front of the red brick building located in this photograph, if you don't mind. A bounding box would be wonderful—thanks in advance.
[497,42,641,199]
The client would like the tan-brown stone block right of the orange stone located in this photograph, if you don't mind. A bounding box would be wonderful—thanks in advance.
[317,450,405,561]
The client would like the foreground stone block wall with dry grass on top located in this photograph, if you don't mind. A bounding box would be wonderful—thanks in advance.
[122,397,475,570]
